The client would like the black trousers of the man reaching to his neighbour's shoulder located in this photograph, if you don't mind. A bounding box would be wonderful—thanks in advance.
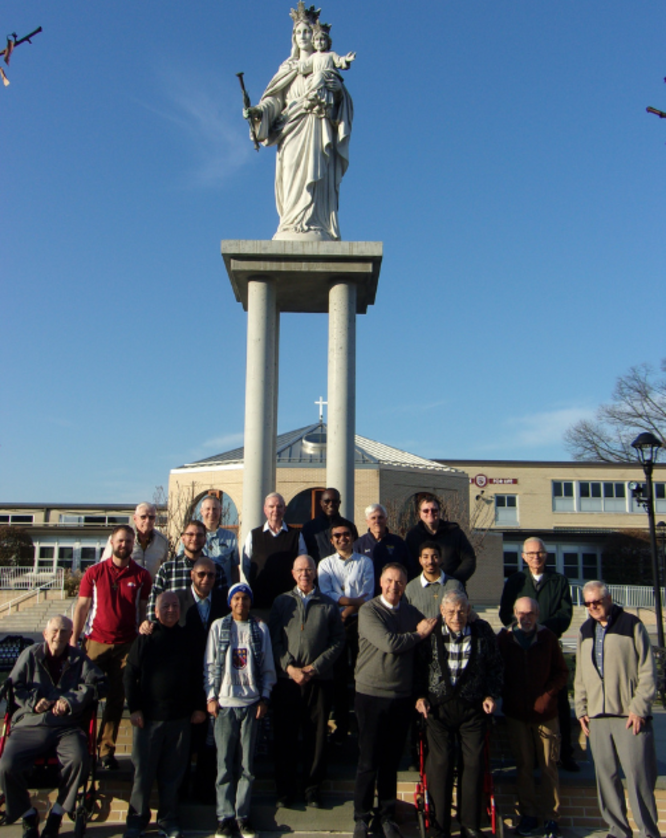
[354,693,413,823]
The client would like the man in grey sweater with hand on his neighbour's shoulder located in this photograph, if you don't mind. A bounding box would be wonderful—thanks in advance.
[354,562,437,838]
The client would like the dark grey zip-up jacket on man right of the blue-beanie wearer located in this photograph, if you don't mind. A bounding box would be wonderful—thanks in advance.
[268,589,345,681]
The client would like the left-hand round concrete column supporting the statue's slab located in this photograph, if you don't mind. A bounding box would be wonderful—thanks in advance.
[241,275,277,543]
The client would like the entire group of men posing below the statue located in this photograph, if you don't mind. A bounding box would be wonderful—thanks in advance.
[0,489,659,838]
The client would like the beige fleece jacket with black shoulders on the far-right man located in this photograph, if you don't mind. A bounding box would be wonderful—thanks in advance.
[575,605,657,719]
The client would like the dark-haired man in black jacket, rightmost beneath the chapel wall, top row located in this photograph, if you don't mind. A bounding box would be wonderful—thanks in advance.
[405,495,476,585]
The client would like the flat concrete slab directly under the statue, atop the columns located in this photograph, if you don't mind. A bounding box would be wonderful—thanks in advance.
[221,239,382,314]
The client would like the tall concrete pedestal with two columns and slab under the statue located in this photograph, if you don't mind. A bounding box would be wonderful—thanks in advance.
[221,240,382,538]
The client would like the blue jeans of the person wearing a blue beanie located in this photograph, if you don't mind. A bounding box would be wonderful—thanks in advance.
[215,702,259,820]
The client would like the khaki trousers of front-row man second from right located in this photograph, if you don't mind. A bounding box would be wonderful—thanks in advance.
[506,717,560,822]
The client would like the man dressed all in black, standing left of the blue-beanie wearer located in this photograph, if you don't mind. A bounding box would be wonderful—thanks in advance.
[124,591,206,838]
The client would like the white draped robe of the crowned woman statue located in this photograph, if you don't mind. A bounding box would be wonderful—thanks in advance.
[255,59,354,241]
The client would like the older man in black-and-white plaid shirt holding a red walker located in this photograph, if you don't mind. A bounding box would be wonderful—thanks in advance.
[416,591,503,838]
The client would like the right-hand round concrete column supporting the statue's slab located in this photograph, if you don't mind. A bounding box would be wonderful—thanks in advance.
[326,279,356,520]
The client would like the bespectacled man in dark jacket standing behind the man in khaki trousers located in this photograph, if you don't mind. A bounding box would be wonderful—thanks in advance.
[500,538,580,772]
